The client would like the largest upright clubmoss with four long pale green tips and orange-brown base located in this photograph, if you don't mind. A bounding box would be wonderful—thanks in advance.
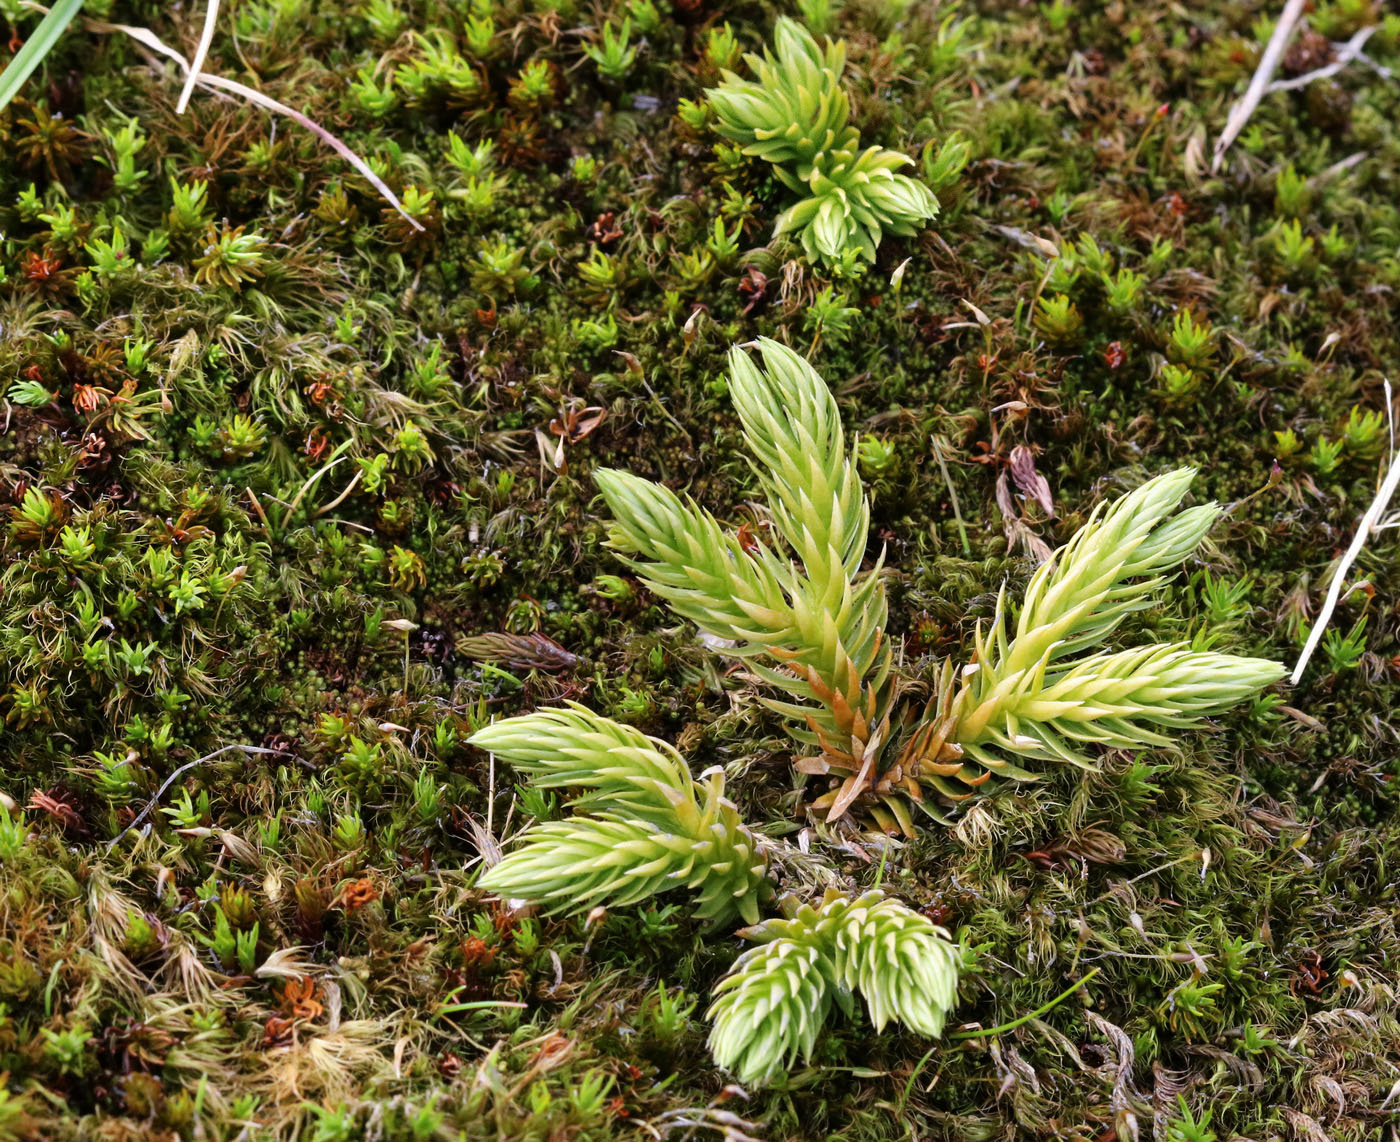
[596,340,1284,833]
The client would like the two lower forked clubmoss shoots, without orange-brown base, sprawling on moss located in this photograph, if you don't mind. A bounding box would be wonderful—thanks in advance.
[470,704,962,1083]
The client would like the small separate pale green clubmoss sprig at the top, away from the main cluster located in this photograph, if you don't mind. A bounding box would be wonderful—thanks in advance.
[706,17,938,263]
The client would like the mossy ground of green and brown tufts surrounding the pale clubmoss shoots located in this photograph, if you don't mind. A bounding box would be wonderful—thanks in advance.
[0,0,1400,1142]
